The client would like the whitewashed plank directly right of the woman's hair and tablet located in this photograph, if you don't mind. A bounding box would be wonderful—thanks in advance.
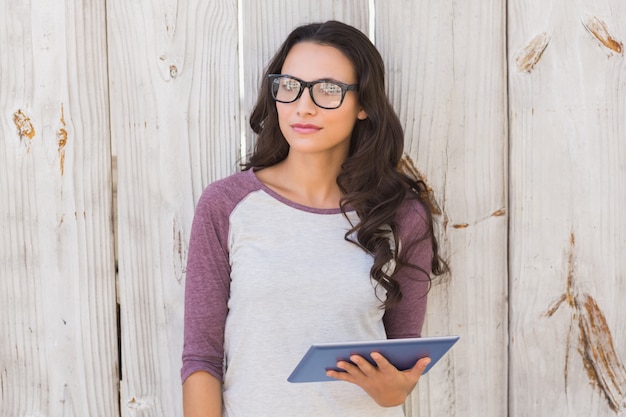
[376,0,508,417]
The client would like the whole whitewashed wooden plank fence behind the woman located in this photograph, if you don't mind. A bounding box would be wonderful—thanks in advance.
[0,0,626,417]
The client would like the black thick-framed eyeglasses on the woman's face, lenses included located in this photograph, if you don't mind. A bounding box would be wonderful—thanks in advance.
[269,74,359,110]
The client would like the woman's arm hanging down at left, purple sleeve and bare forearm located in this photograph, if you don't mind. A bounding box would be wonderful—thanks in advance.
[181,184,230,417]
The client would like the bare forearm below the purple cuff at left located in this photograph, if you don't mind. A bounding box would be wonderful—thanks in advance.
[183,372,222,417]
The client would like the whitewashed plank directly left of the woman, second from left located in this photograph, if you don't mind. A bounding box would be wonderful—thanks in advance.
[107,0,240,417]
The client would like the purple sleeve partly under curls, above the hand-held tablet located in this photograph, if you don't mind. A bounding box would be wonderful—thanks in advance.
[383,200,433,339]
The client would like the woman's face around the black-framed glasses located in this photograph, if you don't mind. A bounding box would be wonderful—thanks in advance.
[276,42,367,159]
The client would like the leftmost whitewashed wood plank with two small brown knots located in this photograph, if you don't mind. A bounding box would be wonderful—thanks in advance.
[0,0,119,416]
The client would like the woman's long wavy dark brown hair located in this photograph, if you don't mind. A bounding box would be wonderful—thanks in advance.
[243,21,447,308]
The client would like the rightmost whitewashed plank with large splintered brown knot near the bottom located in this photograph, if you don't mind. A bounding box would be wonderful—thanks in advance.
[508,0,626,417]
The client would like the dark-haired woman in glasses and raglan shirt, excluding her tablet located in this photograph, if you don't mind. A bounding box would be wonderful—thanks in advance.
[181,21,445,417]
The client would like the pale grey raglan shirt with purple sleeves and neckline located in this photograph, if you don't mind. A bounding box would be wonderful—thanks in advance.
[181,170,432,417]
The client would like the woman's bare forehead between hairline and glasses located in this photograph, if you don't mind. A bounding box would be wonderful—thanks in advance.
[281,42,357,84]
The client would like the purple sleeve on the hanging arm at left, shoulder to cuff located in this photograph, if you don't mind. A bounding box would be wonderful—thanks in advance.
[181,186,230,382]
